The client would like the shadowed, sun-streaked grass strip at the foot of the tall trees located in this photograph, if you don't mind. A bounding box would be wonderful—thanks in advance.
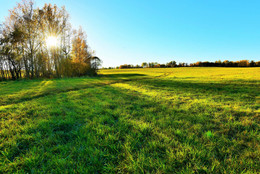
[0,74,149,106]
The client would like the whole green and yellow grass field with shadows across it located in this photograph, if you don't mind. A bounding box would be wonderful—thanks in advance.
[0,68,260,173]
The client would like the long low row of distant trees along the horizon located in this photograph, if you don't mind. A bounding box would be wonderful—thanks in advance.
[117,60,260,69]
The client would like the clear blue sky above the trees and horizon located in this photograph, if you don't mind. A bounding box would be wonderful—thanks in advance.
[0,0,260,67]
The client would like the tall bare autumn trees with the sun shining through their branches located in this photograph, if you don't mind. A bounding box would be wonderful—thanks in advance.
[0,0,101,80]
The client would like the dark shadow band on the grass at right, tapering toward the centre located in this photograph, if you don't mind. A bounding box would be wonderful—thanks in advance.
[133,79,260,104]
